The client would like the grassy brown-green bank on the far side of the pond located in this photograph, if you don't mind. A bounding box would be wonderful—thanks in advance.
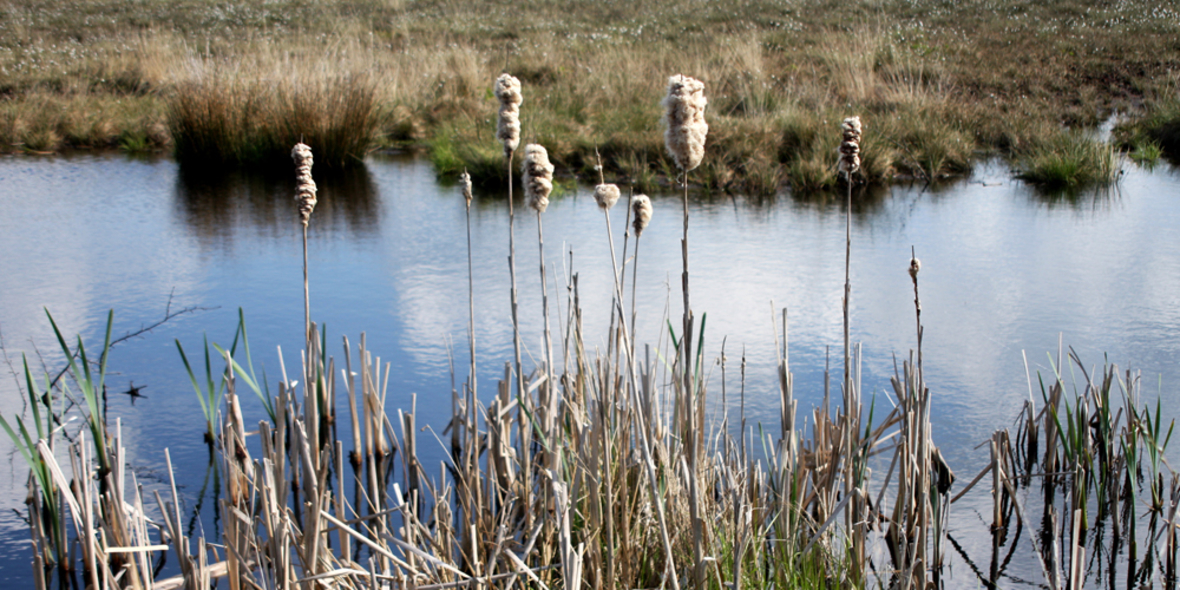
[0,0,1180,192]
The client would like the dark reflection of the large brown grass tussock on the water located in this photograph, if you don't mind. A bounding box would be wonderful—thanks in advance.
[173,160,381,243]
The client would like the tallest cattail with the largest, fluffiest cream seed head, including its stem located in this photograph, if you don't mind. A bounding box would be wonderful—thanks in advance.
[663,74,709,589]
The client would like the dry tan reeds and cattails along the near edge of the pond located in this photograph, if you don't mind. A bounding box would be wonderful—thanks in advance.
[0,76,1180,590]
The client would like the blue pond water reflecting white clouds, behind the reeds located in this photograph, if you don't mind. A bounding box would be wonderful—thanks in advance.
[0,155,1180,588]
